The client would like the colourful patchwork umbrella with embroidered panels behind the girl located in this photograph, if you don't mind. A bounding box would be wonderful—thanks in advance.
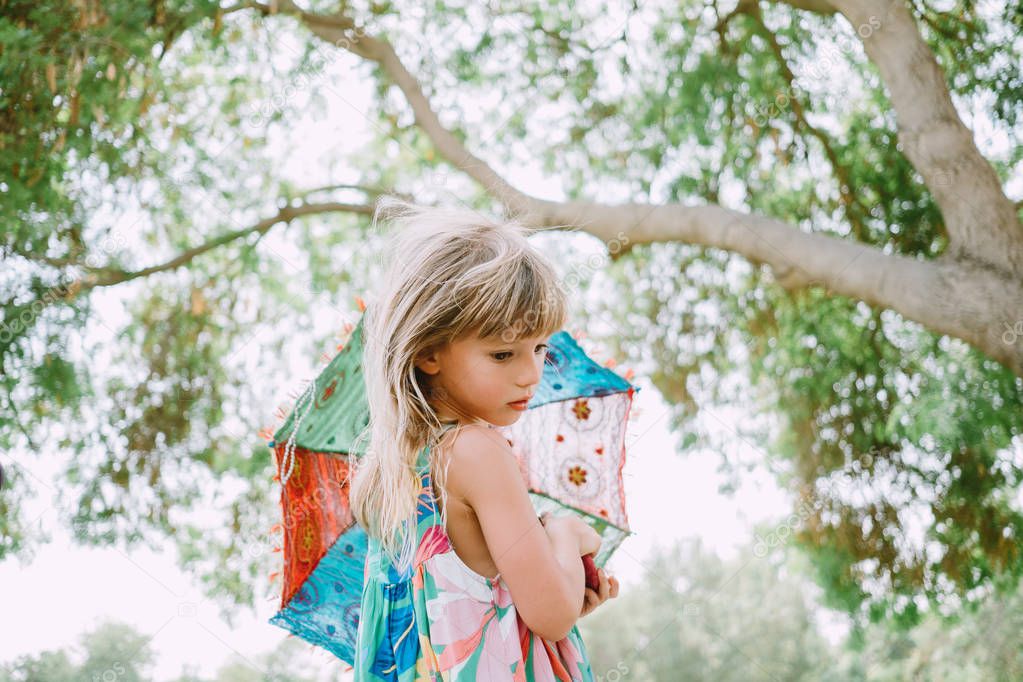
[269,302,639,666]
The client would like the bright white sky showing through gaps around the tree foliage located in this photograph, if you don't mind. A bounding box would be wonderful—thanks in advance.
[6,7,1014,680]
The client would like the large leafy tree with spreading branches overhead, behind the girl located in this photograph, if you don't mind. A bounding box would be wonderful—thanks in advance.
[0,0,1023,624]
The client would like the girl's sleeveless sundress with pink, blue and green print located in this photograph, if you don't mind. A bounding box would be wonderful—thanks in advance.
[355,435,593,682]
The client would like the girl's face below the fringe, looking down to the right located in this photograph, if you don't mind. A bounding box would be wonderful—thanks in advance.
[415,333,550,426]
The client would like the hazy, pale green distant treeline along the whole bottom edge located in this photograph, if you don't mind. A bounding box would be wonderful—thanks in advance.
[7,541,1023,682]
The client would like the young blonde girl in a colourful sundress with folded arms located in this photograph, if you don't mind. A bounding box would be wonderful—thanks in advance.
[351,200,618,682]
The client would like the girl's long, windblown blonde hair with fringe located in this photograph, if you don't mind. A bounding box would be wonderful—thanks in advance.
[350,197,568,574]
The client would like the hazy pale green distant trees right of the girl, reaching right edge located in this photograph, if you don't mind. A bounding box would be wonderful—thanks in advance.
[579,543,1023,682]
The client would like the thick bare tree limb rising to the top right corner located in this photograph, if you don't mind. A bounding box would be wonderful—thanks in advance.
[832,0,1023,273]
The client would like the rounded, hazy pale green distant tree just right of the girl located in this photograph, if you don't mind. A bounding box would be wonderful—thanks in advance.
[579,540,838,682]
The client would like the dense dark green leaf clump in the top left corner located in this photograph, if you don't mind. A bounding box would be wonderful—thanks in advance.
[0,0,217,259]
